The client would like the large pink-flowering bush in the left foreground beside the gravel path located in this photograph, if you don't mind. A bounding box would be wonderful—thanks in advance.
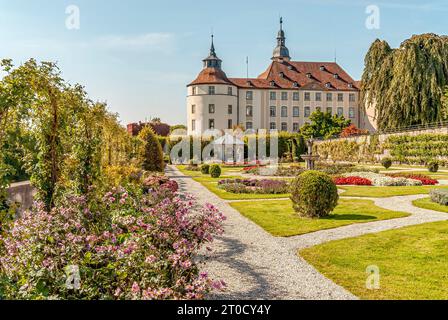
[0,177,225,300]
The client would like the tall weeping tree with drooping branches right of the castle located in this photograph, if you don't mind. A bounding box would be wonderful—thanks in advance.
[361,34,448,129]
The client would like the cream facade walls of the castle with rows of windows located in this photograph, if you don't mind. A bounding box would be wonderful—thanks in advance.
[187,84,365,135]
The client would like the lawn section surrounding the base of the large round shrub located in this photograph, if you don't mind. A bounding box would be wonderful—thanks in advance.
[230,199,408,237]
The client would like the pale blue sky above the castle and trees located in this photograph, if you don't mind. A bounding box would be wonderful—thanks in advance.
[0,0,448,124]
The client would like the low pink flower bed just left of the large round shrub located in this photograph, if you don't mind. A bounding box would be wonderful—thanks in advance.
[218,179,289,194]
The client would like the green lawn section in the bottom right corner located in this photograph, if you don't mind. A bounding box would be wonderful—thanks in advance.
[299,221,448,300]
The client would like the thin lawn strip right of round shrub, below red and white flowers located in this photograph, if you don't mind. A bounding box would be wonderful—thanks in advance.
[338,186,448,198]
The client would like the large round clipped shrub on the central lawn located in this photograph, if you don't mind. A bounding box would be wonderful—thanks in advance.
[291,171,339,218]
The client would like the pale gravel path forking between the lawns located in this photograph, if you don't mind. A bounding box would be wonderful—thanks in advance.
[167,166,448,300]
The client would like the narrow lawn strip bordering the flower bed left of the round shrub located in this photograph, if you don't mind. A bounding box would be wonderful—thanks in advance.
[178,166,289,200]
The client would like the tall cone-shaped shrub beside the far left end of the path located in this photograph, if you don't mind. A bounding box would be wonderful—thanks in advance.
[138,127,165,172]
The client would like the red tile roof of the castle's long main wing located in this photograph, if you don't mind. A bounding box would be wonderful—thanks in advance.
[229,61,359,91]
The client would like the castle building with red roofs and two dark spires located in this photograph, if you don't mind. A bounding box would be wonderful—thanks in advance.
[187,19,374,135]
